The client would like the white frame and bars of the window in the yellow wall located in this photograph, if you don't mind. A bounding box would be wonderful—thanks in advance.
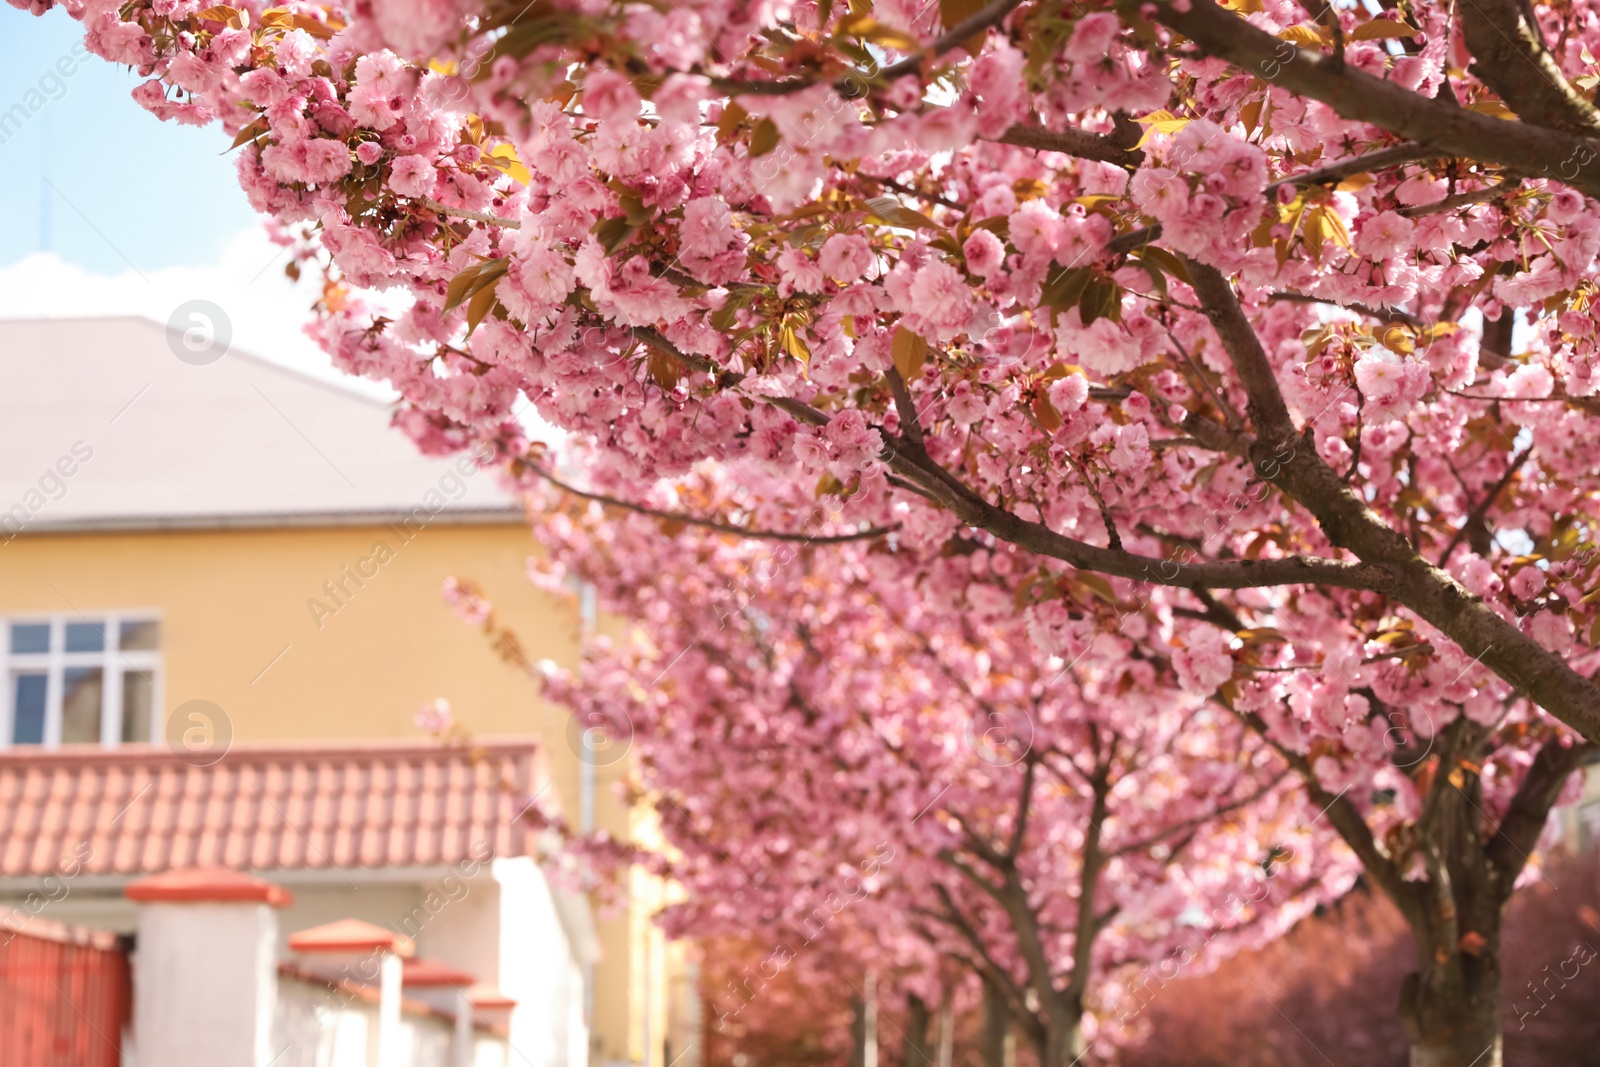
[0,609,166,749]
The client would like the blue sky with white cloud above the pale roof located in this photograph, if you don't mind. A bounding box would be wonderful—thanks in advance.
[0,5,366,385]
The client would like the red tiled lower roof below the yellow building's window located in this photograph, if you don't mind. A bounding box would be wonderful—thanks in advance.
[0,739,547,877]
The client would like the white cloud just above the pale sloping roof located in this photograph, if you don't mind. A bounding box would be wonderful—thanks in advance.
[0,227,394,398]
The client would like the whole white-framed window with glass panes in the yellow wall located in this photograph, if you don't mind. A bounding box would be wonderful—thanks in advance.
[0,614,162,747]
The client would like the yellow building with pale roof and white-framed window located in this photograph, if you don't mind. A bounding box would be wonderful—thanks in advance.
[0,318,698,1067]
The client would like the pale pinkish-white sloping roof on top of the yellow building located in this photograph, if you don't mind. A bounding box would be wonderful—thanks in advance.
[0,317,520,541]
